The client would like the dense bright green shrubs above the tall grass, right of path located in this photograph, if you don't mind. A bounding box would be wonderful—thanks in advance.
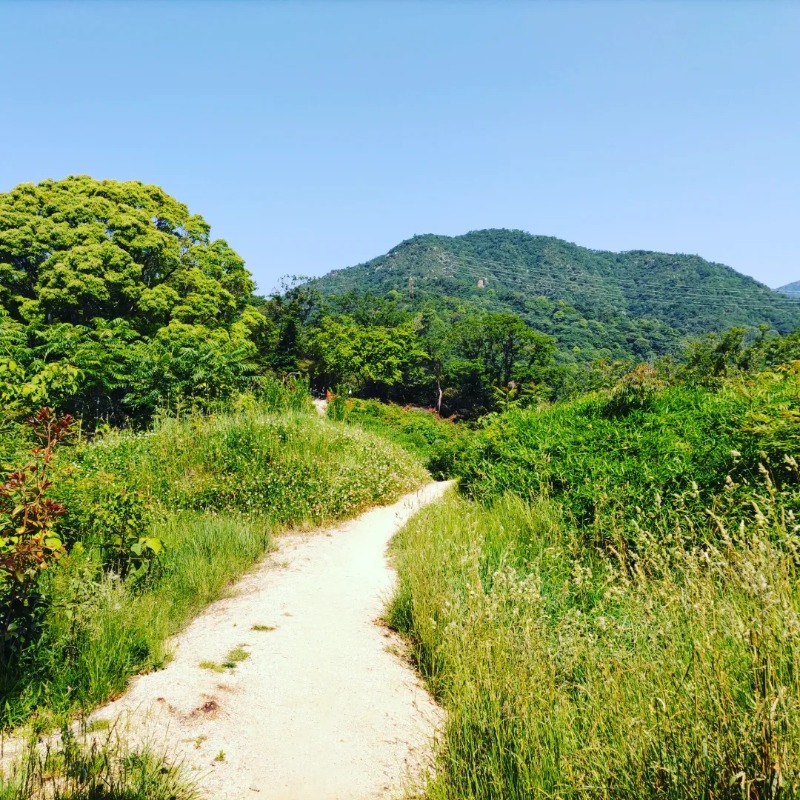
[450,369,798,546]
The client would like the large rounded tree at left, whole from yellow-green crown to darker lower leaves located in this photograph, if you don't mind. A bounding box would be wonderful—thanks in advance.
[0,176,260,422]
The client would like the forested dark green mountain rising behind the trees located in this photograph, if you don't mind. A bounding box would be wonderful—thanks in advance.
[315,229,800,361]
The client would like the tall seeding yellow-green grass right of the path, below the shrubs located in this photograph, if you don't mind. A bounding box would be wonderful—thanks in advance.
[391,490,800,800]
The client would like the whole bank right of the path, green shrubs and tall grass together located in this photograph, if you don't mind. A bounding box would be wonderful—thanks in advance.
[391,368,800,800]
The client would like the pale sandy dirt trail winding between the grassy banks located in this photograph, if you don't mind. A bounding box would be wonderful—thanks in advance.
[93,483,448,800]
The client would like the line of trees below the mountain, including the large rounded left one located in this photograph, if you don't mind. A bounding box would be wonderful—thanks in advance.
[0,176,800,428]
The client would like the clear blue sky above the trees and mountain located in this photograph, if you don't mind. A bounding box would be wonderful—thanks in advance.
[0,0,800,291]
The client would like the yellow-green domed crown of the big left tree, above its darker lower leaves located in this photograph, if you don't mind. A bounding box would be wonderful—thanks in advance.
[0,175,254,333]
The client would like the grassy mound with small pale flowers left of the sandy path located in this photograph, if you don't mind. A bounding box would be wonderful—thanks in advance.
[0,384,426,800]
